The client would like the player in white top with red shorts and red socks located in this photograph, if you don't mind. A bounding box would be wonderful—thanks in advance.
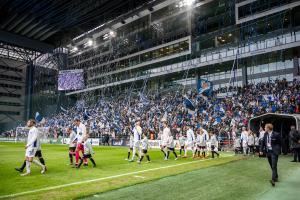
[73,117,88,166]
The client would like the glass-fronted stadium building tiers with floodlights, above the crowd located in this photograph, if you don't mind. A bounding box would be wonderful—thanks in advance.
[67,0,300,95]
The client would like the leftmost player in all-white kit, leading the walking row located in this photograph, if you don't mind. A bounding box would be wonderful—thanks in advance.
[21,119,45,176]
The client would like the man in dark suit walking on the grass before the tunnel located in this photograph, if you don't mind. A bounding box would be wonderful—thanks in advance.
[260,124,281,187]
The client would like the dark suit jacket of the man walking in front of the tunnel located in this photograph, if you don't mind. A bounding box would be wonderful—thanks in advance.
[260,131,281,155]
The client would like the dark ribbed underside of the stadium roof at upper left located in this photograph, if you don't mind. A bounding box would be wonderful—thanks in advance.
[0,0,153,51]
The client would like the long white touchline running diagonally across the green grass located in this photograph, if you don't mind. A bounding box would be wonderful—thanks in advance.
[0,155,233,199]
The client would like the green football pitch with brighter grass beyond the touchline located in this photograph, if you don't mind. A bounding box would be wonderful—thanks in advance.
[0,143,300,200]
